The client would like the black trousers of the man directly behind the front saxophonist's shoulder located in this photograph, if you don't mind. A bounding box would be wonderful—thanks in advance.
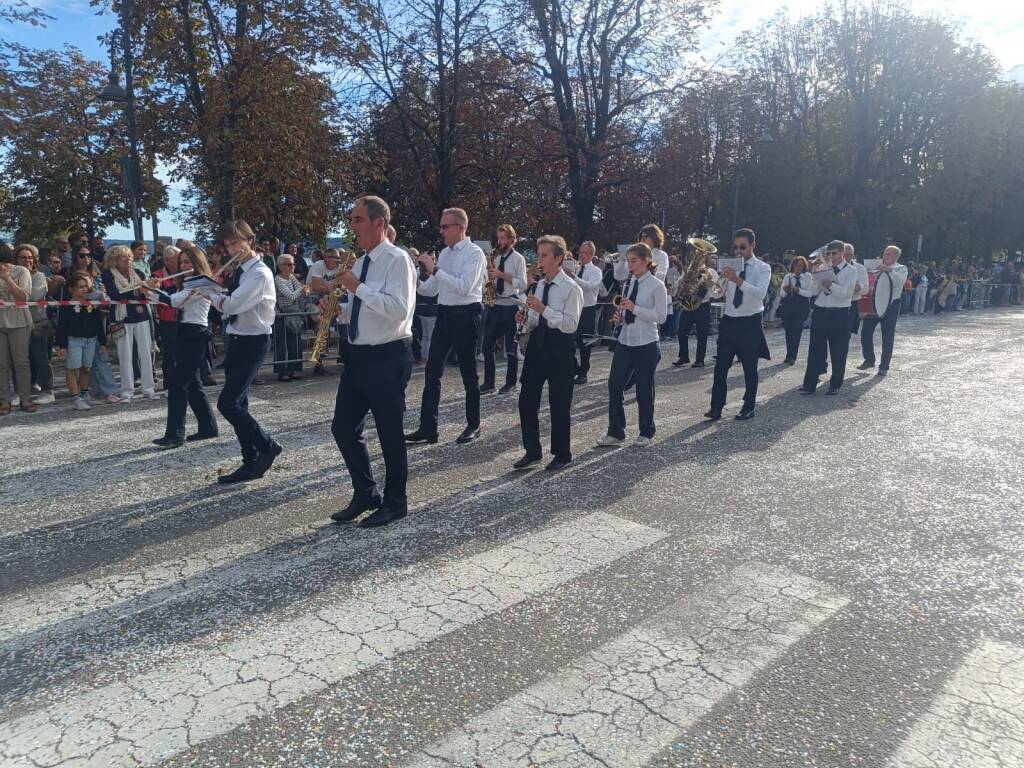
[420,304,481,434]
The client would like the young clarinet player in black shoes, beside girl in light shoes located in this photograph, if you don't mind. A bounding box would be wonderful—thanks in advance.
[512,234,596,470]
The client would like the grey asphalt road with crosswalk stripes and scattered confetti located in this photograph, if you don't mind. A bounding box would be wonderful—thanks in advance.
[0,309,1024,768]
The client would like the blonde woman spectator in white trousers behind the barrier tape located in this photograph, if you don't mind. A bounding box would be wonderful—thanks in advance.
[102,246,157,403]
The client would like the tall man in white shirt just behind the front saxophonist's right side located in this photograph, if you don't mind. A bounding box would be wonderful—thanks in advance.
[406,208,487,442]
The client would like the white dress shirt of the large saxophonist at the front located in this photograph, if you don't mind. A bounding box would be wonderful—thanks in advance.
[340,241,416,346]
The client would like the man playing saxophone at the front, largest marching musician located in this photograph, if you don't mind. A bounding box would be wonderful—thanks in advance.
[323,196,416,527]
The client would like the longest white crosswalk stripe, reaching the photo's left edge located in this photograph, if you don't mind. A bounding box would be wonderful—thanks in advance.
[0,513,666,768]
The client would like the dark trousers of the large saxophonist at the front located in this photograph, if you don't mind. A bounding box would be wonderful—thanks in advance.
[331,339,413,509]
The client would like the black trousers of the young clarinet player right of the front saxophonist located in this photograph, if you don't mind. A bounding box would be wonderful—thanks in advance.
[519,329,575,462]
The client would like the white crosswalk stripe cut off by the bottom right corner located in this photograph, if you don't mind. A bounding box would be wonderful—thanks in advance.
[888,640,1024,768]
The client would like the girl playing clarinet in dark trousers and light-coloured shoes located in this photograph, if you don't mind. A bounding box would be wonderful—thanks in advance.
[597,243,669,447]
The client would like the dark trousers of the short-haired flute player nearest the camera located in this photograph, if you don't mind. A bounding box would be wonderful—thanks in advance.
[217,334,270,464]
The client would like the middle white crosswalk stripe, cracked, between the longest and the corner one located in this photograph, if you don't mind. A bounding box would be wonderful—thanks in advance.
[409,563,847,768]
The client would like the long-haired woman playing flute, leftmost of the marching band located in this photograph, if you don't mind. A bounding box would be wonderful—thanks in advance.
[146,246,218,450]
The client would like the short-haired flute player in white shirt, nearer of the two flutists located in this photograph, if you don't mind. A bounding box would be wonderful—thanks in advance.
[212,219,282,483]
